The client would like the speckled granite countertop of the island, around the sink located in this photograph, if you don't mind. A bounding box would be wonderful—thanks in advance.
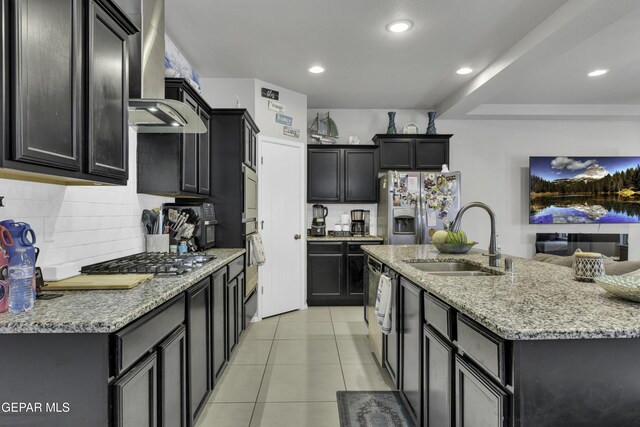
[363,245,640,340]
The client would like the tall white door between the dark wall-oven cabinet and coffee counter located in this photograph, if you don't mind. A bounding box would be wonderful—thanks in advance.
[258,137,306,318]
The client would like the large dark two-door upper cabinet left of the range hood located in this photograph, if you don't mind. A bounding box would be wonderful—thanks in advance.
[0,0,137,184]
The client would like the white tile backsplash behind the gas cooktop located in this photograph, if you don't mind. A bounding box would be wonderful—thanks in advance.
[0,130,173,279]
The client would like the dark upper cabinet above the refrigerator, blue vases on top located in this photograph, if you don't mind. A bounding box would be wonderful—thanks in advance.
[373,134,453,170]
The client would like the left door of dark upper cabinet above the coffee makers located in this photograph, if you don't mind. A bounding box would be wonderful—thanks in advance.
[307,148,342,202]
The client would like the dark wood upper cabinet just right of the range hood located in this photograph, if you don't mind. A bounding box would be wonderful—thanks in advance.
[138,78,211,198]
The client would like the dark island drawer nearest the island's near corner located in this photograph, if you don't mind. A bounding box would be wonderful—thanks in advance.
[456,313,506,384]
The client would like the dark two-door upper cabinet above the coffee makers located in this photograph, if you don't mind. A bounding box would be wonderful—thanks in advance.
[307,145,378,203]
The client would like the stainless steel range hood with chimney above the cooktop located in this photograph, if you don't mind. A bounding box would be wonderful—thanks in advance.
[116,0,207,133]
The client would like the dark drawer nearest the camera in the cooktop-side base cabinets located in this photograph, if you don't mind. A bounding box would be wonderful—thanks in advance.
[111,294,185,376]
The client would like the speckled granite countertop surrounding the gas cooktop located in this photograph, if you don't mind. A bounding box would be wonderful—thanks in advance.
[0,249,245,334]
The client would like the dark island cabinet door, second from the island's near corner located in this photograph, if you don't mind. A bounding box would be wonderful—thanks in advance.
[422,326,454,427]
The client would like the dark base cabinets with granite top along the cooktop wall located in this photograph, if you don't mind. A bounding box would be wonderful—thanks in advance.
[0,249,245,426]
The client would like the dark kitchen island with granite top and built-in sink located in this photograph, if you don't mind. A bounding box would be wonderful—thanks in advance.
[364,245,640,427]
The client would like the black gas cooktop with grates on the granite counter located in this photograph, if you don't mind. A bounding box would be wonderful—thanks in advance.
[80,252,216,275]
